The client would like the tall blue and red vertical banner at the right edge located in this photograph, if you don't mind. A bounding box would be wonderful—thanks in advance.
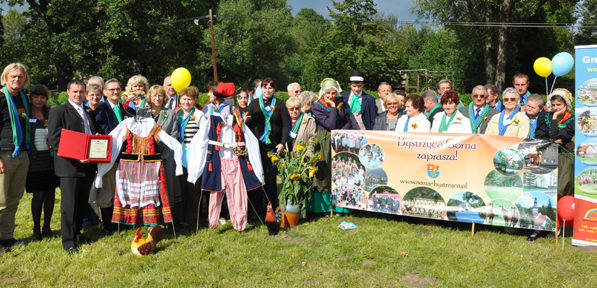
[572,45,597,246]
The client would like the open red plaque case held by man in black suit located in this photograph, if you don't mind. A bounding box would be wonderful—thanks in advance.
[58,129,112,163]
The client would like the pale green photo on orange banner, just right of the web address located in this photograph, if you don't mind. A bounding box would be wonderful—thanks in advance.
[485,170,523,201]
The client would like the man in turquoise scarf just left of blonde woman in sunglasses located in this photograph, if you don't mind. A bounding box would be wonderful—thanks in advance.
[458,85,500,134]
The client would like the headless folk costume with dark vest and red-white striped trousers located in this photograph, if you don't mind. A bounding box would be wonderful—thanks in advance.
[187,113,263,231]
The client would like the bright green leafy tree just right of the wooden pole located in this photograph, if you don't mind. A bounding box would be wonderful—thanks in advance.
[199,0,294,89]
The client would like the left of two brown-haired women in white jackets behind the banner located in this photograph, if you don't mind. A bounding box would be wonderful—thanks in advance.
[396,95,431,132]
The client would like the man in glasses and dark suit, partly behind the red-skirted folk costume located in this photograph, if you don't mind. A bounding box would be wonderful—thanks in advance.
[93,78,135,236]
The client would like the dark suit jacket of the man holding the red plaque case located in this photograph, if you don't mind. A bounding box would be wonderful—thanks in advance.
[48,101,97,178]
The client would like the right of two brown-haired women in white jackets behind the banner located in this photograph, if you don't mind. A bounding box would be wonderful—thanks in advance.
[431,90,472,133]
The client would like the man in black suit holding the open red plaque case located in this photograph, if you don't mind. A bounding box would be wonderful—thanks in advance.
[48,80,97,254]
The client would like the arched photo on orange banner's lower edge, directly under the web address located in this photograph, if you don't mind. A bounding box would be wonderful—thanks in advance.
[402,187,447,219]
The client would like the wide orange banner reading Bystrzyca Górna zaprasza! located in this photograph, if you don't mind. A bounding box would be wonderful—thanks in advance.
[331,130,558,231]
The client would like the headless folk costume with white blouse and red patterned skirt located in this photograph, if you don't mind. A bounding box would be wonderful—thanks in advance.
[95,118,182,225]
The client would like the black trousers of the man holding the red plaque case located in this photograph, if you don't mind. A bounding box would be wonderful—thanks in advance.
[60,173,95,249]
